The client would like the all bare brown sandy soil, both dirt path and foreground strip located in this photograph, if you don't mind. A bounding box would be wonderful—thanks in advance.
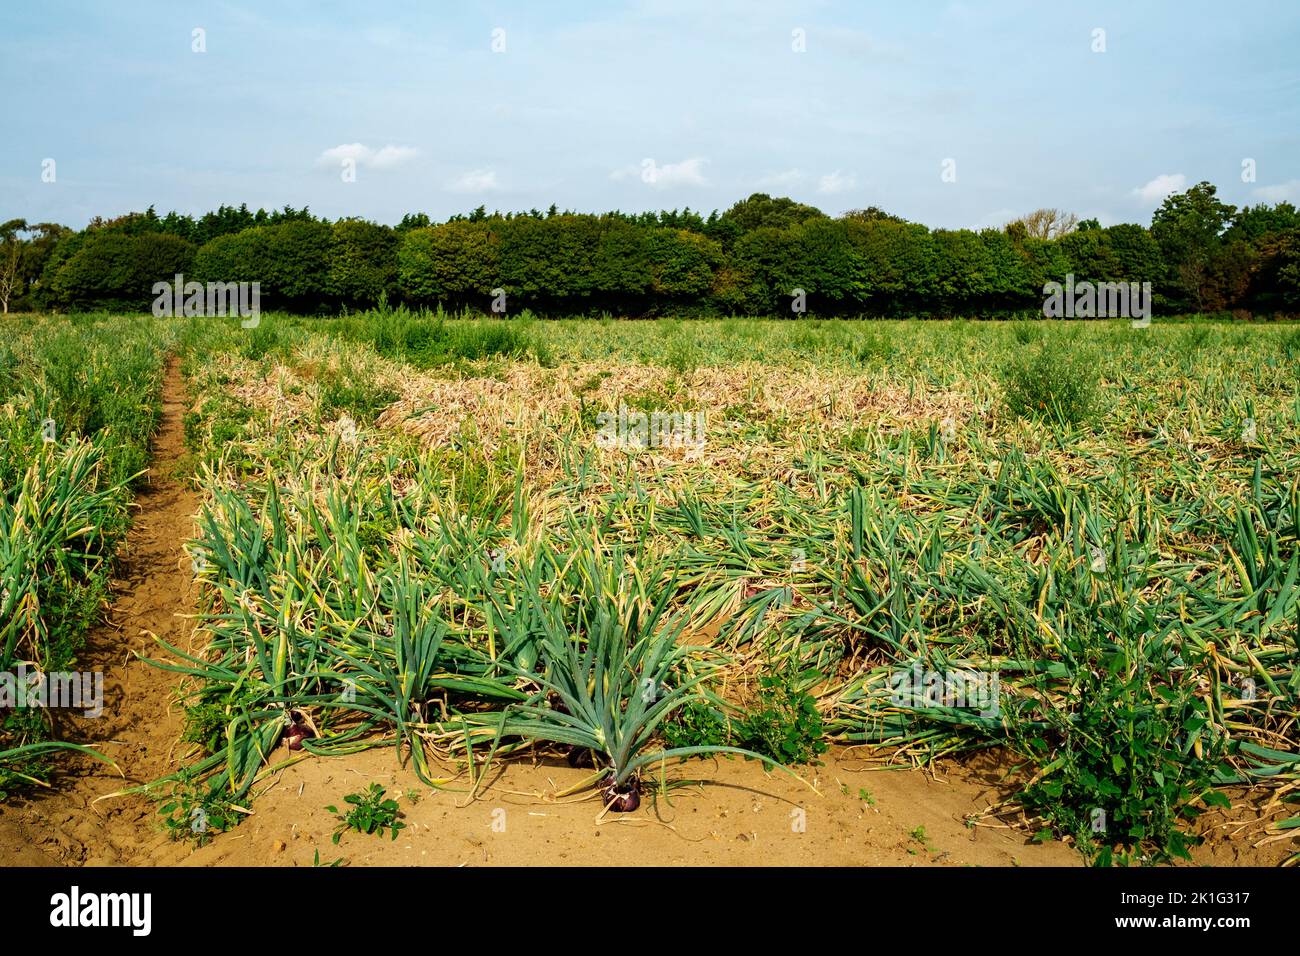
[0,362,1295,866]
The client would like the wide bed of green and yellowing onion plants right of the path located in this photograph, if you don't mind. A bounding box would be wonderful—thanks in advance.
[162,323,1300,856]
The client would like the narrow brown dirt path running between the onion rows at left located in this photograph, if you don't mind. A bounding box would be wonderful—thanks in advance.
[0,359,199,865]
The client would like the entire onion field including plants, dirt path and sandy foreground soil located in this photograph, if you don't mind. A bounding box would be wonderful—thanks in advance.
[0,307,1300,865]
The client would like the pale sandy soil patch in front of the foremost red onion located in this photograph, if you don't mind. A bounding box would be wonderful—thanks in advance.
[144,749,1080,866]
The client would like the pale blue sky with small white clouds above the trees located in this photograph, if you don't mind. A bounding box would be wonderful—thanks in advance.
[0,0,1300,228]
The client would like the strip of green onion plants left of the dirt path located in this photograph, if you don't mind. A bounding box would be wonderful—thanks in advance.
[0,319,173,786]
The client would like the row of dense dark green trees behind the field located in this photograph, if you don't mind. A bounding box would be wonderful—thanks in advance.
[0,182,1300,316]
